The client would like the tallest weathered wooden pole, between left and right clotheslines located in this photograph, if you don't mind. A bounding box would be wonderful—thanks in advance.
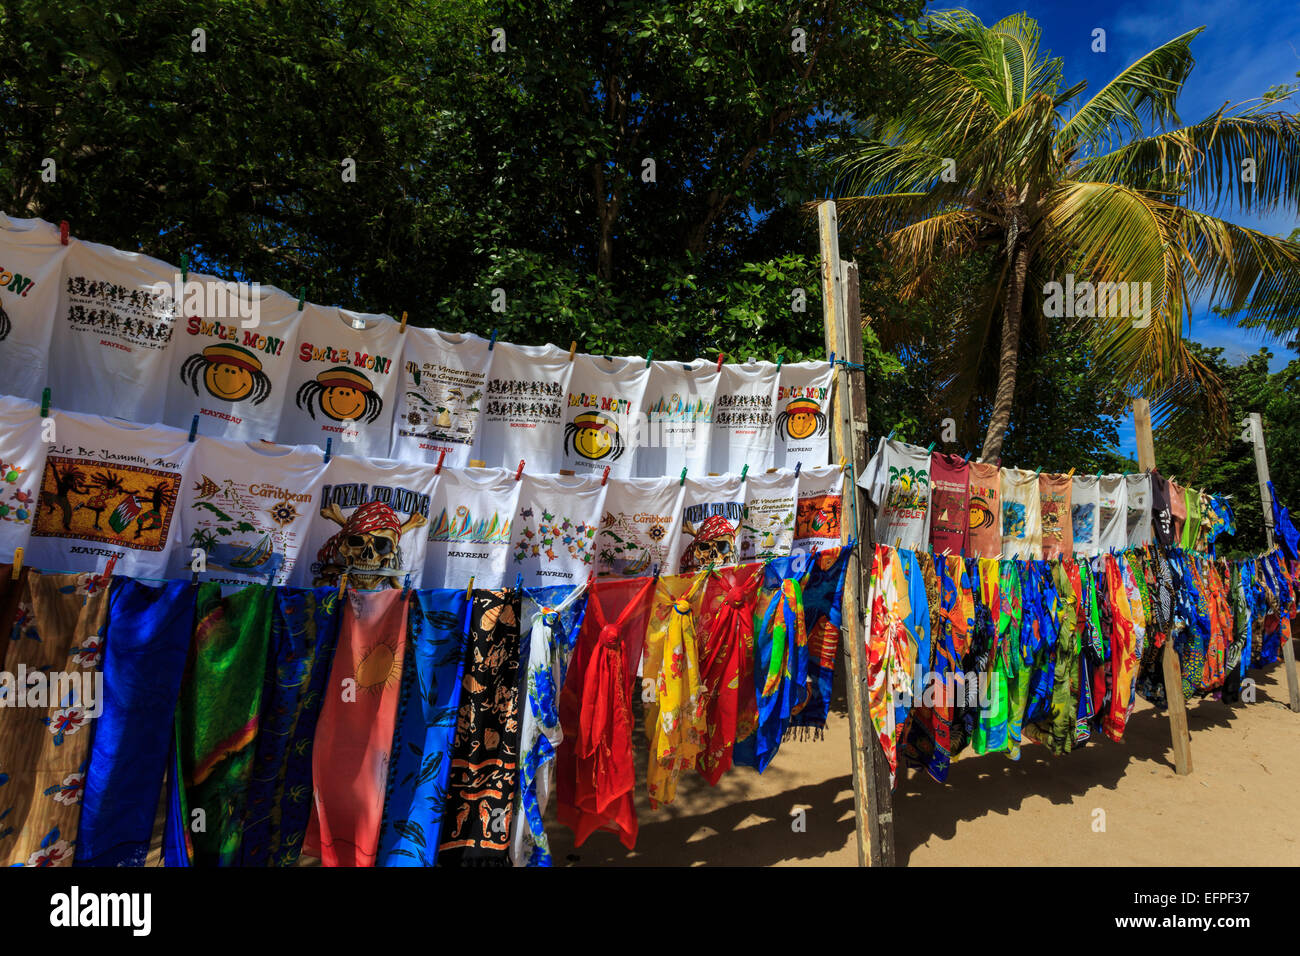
[818,202,894,866]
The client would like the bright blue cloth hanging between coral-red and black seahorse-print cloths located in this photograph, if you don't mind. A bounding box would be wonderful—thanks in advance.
[378,588,469,866]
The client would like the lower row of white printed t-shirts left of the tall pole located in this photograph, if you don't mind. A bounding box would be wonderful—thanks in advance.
[0,397,842,588]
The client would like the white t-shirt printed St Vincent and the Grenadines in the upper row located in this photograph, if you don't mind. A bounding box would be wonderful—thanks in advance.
[393,328,497,468]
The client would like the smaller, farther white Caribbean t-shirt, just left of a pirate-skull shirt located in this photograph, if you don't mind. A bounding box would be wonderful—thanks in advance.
[595,477,685,578]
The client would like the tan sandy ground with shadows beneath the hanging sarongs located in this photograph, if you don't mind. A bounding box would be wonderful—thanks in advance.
[547,662,1300,866]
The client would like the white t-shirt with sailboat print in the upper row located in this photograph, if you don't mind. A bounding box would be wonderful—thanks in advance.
[637,359,722,481]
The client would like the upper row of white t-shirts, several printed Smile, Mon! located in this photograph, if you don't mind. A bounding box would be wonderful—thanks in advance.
[0,216,831,477]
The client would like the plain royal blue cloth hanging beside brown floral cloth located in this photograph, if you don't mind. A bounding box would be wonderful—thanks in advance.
[74,578,195,866]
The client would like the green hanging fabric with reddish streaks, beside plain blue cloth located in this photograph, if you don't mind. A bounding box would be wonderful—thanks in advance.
[164,584,274,866]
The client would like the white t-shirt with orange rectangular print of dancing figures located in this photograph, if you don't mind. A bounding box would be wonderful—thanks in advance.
[27,411,194,578]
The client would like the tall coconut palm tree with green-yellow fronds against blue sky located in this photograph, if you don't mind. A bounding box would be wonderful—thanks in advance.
[824,10,1300,460]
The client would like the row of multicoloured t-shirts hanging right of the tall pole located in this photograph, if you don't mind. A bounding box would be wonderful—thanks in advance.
[858,438,1212,558]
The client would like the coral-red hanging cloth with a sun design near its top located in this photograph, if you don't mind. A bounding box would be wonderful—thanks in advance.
[303,588,408,866]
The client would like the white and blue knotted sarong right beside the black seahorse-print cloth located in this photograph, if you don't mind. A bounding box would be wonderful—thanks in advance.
[510,583,586,866]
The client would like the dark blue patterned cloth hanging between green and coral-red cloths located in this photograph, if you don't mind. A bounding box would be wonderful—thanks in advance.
[241,588,343,866]
